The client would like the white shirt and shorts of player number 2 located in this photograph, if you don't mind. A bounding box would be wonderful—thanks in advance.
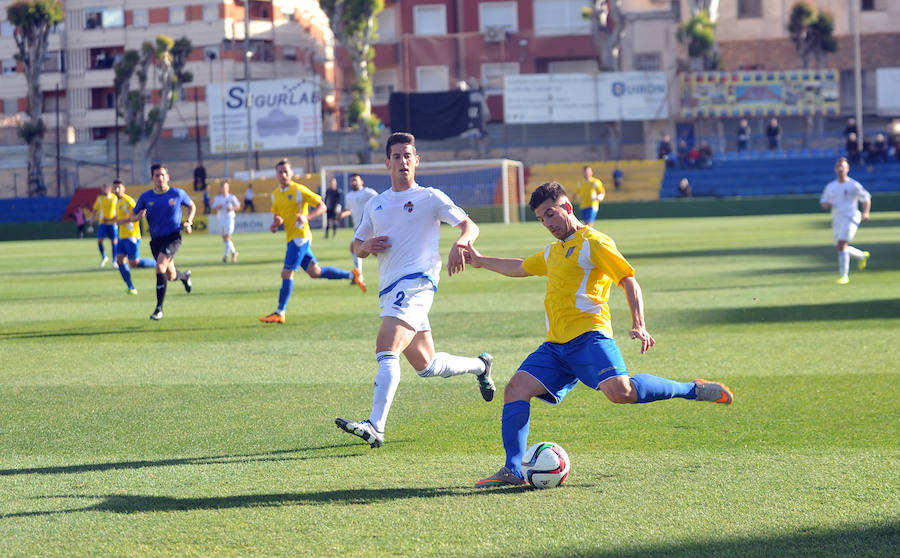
[354,184,467,331]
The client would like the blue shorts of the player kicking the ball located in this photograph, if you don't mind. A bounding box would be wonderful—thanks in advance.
[519,331,628,405]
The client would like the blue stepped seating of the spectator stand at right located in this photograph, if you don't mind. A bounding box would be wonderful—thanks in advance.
[659,154,900,198]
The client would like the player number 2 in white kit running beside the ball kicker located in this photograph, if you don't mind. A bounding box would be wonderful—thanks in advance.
[335,132,495,448]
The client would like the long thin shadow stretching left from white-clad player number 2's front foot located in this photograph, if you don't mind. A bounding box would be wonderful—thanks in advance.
[0,444,362,477]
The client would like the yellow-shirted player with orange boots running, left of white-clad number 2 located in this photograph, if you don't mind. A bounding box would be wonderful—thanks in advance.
[259,159,365,324]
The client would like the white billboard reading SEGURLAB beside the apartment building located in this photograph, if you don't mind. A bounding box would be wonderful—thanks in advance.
[206,77,322,153]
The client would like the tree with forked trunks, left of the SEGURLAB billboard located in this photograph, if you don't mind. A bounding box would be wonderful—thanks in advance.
[113,35,194,184]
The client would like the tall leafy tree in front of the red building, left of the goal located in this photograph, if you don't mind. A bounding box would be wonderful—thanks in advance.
[319,0,384,162]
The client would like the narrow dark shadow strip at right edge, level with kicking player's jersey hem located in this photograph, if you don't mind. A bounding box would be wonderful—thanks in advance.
[674,299,900,324]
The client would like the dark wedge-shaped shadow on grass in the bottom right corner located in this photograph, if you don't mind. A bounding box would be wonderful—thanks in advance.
[546,521,900,558]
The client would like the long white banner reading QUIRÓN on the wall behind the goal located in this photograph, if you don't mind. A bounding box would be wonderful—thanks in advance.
[503,72,669,124]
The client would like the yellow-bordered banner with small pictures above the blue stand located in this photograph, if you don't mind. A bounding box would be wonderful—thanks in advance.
[679,70,840,118]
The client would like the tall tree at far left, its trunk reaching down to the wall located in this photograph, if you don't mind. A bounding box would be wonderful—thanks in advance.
[6,0,63,196]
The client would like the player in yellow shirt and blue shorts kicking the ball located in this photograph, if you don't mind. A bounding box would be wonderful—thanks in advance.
[466,182,733,487]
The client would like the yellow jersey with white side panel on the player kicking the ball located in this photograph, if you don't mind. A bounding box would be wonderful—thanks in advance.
[522,227,634,343]
